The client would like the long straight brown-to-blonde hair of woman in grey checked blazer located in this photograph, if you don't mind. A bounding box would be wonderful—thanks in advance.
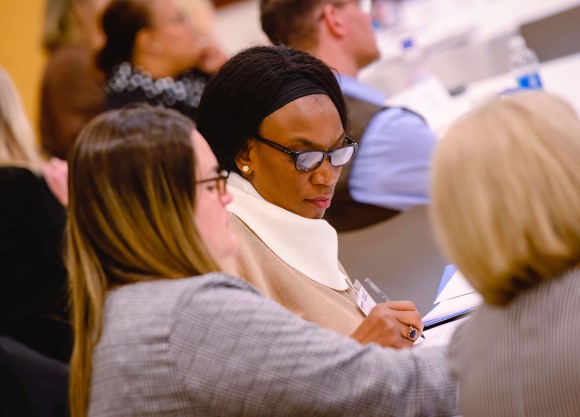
[67,106,219,417]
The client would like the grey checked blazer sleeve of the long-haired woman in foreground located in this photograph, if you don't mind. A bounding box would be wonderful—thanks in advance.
[171,274,455,416]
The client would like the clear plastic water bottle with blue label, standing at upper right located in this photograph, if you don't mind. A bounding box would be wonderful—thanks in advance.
[509,36,542,90]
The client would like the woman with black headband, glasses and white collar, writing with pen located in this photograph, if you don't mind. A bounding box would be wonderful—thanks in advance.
[198,46,423,348]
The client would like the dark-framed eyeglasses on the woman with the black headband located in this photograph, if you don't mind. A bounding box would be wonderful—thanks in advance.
[254,135,358,172]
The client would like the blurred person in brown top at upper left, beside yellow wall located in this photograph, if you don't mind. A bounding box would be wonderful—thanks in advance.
[40,0,109,159]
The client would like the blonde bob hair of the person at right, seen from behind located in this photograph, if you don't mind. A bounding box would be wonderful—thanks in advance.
[432,92,580,305]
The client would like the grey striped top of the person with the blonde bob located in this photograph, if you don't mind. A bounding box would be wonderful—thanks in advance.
[449,269,580,417]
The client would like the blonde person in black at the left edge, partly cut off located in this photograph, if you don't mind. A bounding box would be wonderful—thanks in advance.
[0,67,71,362]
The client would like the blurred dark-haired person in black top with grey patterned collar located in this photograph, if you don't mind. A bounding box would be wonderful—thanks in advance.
[98,0,227,119]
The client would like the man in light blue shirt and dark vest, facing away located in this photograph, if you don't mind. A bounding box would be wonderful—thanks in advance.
[260,0,436,231]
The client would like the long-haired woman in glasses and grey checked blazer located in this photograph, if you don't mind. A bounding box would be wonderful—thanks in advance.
[68,108,456,417]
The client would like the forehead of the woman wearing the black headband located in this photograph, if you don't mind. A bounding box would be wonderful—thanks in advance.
[260,94,344,149]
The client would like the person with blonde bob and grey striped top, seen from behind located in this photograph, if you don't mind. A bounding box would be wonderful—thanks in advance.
[432,92,580,417]
